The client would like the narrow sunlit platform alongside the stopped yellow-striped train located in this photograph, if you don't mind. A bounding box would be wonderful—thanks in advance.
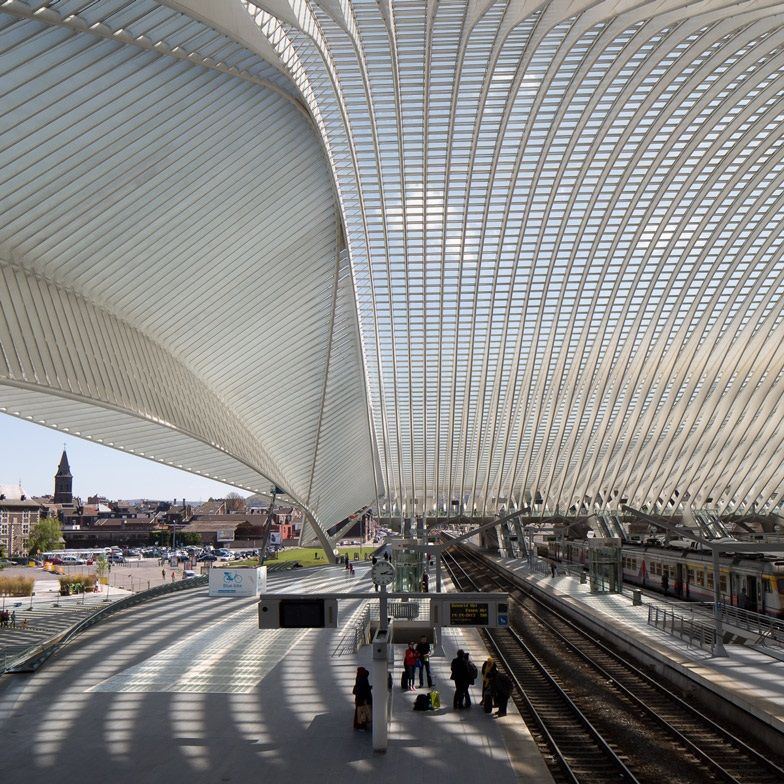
[490,556,784,733]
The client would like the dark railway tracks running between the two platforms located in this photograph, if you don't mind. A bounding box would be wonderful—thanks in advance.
[446,550,784,784]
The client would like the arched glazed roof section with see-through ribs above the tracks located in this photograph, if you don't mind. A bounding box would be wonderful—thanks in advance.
[249,0,784,515]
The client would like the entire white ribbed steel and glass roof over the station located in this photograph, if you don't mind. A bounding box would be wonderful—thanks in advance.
[0,0,784,540]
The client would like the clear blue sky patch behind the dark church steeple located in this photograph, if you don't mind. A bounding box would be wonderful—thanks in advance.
[0,414,248,501]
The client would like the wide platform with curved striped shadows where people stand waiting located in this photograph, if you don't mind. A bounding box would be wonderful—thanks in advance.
[0,563,551,784]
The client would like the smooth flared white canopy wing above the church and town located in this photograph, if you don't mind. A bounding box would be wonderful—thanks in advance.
[0,0,375,540]
